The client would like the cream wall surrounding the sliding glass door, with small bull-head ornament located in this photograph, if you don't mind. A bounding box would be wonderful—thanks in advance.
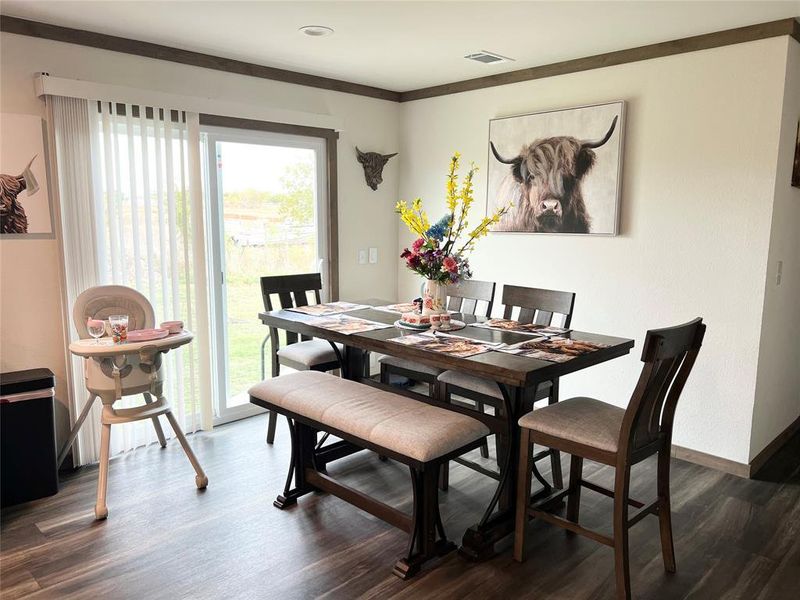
[0,33,400,442]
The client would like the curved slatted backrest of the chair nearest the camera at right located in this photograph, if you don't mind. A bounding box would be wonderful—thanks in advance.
[619,318,706,456]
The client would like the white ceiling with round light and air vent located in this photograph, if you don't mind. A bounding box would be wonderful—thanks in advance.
[0,0,800,91]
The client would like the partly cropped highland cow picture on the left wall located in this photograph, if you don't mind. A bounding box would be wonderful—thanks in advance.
[0,113,53,237]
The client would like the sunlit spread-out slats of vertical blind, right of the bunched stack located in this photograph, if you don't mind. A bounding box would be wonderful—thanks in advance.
[90,102,199,440]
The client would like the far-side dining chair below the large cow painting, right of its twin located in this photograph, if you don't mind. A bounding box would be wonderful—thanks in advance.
[438,285,575,489]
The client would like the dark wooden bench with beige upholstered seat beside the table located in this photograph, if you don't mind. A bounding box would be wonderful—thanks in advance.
[249,371,489,579]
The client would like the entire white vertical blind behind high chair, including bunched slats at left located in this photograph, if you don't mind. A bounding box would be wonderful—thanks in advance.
[51,97,212,464]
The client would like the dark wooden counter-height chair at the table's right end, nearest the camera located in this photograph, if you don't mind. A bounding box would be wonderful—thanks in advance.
[514,318,706,599]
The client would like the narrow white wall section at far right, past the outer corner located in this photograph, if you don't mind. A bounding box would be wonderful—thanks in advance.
[750,42,800,459]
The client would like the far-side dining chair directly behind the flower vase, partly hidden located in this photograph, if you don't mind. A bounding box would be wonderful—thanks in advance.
[378,279,497,404]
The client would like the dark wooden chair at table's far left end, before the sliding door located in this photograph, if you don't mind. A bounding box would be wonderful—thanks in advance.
[261,273,342,444]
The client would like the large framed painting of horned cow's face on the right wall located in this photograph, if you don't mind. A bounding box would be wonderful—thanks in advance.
[487,101,625,235]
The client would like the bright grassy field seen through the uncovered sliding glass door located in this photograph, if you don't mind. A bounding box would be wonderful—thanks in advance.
[217,142,318,407]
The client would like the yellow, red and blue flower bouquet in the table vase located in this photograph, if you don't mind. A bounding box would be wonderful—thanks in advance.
[395,152,510,284]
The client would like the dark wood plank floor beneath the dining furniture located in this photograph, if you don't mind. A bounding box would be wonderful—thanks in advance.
[0,417,800,600]
